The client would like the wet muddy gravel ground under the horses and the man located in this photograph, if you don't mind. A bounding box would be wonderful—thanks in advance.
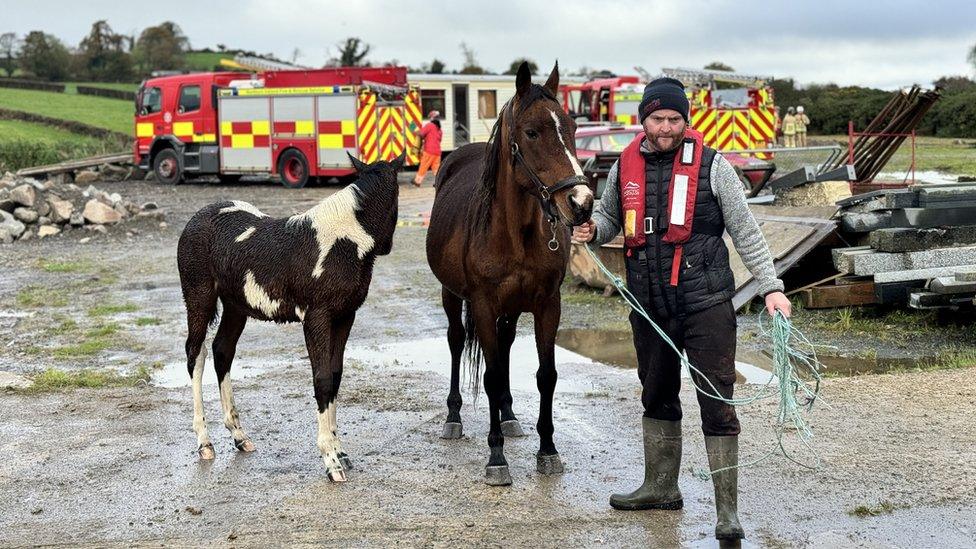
[0,174,976,547]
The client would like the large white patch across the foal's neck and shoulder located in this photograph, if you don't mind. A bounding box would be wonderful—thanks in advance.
[287,185,375,278]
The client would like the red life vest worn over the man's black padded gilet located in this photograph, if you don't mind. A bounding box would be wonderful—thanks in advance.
[617,128,703,286]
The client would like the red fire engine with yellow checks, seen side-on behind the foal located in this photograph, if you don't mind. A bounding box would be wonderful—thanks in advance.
[134,67,421,188]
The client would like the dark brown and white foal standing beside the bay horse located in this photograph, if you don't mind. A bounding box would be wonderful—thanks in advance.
[176,155,404,482]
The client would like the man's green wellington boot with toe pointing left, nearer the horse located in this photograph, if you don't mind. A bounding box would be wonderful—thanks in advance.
[610,417,684,511]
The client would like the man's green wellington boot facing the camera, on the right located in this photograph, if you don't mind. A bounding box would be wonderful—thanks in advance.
[705,436,745,540]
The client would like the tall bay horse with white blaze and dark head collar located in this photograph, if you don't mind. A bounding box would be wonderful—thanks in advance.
[427,63,593,486]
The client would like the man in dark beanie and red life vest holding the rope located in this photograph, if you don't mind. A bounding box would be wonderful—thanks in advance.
[573,78,790,540]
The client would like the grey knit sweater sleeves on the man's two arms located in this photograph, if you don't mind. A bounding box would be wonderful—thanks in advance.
[593,154,783,295]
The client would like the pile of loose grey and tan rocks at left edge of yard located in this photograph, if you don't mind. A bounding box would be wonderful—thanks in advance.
[0,173,163,243]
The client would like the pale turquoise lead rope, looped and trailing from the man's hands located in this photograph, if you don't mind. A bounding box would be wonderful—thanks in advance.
[583,244,823,480]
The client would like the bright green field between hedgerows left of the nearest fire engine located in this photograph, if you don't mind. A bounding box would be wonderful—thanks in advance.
[0,88,134,134]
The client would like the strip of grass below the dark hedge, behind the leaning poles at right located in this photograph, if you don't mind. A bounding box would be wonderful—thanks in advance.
[810,135,976,175]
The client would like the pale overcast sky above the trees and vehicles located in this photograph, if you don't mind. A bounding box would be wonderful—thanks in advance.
[7,0,976,89]
